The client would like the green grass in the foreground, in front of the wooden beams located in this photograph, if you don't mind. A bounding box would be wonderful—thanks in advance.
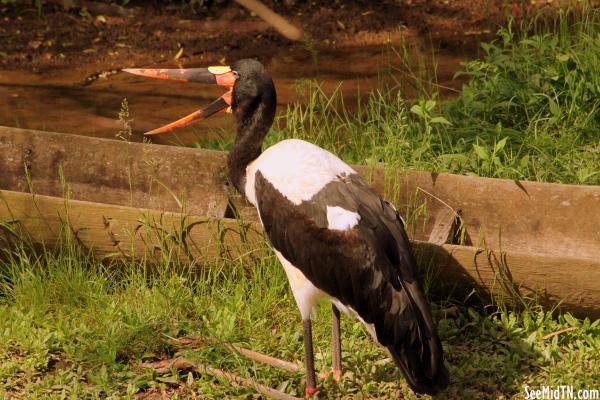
[0,234,600,398]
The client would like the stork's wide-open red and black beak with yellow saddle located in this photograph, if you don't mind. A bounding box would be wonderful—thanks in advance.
[123,66,238,136]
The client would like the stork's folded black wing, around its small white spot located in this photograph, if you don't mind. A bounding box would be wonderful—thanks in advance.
[256,171,448,394]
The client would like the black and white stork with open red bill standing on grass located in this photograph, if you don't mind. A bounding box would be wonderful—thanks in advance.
[124,59,449,396]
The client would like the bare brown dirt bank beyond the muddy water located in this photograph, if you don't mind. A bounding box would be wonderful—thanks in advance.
[0,0,522,72]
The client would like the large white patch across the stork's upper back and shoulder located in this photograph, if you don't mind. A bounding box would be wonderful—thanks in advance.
[244,139,356,205]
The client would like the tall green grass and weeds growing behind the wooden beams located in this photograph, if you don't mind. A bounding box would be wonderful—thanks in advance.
[205,9,600,185]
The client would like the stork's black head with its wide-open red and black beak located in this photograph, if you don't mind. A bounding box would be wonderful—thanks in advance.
[123,59,277,135]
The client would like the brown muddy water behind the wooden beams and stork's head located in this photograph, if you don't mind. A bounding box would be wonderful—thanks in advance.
[0,39,474,145]
